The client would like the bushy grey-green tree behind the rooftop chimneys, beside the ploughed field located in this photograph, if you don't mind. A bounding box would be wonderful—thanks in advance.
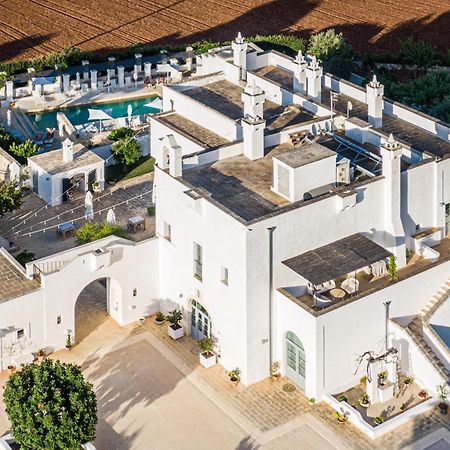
[308,28,355,78]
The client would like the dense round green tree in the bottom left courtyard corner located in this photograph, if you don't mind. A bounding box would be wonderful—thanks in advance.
[3,359,98,450]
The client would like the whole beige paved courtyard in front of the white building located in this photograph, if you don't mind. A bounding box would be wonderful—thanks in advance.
[0,310,450,450]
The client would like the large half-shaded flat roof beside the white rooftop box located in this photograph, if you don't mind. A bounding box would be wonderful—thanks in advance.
[183,144,338,222]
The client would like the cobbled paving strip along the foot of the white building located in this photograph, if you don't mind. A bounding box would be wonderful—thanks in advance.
[145,319,450,450]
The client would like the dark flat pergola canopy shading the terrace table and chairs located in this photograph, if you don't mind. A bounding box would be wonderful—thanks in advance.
[282,233,392,286]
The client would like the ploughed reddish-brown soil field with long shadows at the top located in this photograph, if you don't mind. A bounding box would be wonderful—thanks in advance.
[0,0,450,61]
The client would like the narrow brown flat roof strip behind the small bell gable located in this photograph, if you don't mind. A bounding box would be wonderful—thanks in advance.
[154,113,230,148]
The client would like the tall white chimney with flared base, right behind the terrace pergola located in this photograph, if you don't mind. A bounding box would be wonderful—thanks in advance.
[380,134,406,267]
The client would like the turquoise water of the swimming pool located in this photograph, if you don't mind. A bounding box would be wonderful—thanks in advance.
[28,96,159,130]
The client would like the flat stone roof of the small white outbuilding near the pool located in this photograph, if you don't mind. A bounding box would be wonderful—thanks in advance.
[29,144,103,174]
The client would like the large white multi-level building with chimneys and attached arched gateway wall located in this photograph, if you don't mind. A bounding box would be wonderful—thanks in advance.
[0,36,450,426]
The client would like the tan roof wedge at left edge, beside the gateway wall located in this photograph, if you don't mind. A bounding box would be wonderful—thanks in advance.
[0,253,40,303]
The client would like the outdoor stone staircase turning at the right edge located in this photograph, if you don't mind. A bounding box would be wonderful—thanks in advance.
[406,280,450,385]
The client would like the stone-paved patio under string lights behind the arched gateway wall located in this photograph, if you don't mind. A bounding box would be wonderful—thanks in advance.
[0,174,154,258]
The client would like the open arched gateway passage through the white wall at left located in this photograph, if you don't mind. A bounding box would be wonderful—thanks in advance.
[73,278,121,344]
